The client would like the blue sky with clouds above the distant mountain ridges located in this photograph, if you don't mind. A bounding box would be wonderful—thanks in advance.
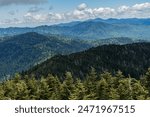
[0,0,150,28]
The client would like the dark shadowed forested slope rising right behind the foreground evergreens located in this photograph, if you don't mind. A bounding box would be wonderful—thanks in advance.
[24,43,150,78]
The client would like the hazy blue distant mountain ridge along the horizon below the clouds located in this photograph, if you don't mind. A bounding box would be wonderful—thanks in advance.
[0,18,150,40]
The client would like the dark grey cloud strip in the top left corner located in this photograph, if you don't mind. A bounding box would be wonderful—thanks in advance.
[0,0,48,6]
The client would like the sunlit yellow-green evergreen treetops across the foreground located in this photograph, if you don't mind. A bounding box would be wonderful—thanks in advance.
[0,68,150,100]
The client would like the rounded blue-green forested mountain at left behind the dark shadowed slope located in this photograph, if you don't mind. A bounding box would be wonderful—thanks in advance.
[0,32,91,78]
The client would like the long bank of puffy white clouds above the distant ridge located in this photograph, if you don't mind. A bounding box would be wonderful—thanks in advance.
[1,2,150,24]
